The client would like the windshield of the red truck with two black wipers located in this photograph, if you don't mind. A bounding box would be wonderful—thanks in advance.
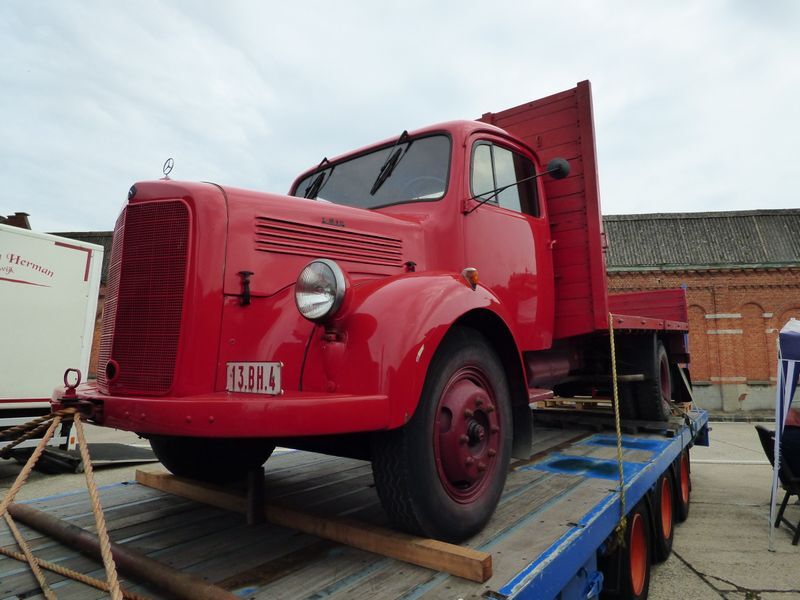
[292,135,450,208]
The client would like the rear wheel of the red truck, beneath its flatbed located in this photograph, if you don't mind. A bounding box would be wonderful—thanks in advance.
[636,336,672,421]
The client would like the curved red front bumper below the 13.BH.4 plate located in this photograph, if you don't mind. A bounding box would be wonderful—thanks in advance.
[52,383,389,437]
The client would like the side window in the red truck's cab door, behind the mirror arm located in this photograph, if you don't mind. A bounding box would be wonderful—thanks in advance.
[472,142,539,217]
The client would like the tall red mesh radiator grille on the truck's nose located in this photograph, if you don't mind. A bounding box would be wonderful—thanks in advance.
[97,200,189,395]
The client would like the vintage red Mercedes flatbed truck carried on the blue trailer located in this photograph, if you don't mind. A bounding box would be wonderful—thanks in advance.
[55,82,688,541]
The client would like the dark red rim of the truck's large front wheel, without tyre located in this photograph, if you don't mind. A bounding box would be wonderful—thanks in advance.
[433,366,501,504]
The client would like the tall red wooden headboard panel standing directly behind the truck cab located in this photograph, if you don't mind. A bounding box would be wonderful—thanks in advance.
[479,81,608,338]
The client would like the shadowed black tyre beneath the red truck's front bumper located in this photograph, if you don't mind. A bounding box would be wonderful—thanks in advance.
[150,435,275,483]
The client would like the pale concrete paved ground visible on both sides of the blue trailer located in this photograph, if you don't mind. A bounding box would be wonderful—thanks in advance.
[0,423,800,600]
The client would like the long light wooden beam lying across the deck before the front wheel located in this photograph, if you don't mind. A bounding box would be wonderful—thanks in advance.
[136,469,492,582]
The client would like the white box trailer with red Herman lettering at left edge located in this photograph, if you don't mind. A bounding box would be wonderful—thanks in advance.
[0,224,103,449]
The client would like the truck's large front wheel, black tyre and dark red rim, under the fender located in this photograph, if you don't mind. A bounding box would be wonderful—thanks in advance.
[372,328,512,542]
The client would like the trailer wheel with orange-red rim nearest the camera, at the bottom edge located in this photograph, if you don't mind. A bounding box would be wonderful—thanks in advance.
[600,502,652,600]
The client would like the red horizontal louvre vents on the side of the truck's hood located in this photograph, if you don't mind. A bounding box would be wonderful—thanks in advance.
[255,217,403,267]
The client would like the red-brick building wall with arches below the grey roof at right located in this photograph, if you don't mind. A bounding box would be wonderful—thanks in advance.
[608,267,800,411]
